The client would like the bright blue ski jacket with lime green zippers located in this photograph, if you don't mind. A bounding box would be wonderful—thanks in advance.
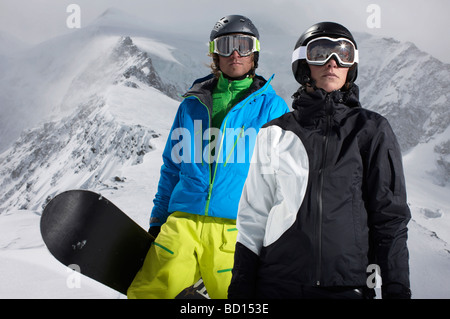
[150,75,289,227]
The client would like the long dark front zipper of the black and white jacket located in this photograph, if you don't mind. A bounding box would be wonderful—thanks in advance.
[316,94,332,286]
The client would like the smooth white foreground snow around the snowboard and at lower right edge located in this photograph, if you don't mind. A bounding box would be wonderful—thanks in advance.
[0,140,450,299]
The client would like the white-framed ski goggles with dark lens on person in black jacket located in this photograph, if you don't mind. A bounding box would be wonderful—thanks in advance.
[292,37,359,67]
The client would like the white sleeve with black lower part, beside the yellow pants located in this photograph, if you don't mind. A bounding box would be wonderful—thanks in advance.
[228,129,276,299]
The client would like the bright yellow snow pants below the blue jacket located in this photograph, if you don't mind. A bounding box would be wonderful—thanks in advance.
[127,212,237,299]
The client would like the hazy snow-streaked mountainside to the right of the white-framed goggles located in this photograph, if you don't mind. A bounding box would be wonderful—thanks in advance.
[356,34,450,151]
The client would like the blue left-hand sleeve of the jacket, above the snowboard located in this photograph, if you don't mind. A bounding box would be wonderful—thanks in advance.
[150,107,182,227]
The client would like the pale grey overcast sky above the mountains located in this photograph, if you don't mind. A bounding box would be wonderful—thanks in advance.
[0,0,450,63]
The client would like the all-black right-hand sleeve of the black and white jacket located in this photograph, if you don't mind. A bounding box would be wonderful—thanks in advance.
[367,118,411,298]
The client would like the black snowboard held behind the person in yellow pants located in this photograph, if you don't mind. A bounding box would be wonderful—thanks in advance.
[40,190,207,299]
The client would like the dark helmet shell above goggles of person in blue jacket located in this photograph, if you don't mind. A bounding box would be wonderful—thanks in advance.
[209,15,259,41]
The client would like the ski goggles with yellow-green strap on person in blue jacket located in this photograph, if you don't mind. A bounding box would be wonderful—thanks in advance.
[209,34,260,57]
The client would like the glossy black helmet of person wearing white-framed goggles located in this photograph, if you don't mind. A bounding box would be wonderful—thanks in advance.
[292,22,358,86]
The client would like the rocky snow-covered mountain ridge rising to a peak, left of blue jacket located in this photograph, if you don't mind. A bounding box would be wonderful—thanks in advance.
[0,37,180,214]
